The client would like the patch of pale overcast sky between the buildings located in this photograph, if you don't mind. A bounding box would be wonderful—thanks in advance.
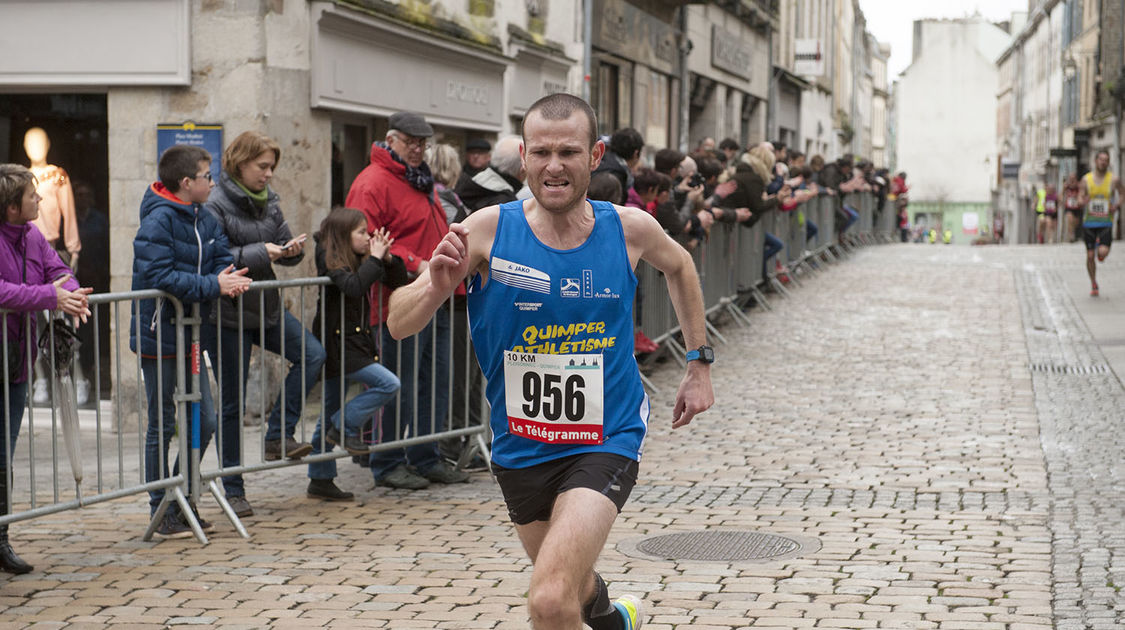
[860,0,1027,82]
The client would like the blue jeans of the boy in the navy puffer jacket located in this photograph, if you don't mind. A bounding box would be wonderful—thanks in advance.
[141,358,215,514]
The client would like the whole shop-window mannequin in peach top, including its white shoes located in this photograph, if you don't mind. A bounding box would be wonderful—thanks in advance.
[24,127,89,405]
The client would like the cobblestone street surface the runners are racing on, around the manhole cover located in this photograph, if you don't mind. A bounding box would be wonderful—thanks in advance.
[0,244,1125,630]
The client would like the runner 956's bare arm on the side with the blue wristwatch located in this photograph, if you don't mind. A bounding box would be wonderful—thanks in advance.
[621,208,714,429]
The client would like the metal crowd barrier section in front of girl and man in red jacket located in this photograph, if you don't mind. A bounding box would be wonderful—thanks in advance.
[200,277,489,541]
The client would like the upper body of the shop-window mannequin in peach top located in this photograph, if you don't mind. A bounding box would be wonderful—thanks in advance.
[24,127,82,269]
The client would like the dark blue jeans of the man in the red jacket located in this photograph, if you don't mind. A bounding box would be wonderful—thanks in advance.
[368,307,450,479]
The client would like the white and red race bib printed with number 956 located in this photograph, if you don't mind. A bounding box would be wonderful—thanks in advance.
[504,351,605,444]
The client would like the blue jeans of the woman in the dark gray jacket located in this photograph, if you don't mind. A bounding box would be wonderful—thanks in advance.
[213,311,325,496]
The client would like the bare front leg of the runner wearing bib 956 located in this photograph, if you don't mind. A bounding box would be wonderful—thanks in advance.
[516,488,618,630]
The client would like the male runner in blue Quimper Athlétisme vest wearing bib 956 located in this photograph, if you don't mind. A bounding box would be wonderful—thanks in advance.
[387,93,714,630]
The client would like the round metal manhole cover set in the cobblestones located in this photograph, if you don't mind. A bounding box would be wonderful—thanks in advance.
[620,530,820,563]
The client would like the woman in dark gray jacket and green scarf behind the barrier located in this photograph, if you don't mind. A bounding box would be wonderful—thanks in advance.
[207,132,325,516]
